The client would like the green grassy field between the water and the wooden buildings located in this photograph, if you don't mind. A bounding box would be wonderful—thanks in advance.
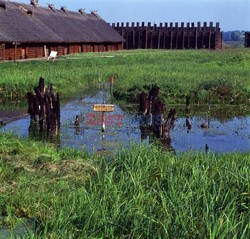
[0,49,250,104]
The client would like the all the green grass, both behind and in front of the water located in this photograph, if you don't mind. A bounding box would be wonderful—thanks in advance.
[0,49,250,239]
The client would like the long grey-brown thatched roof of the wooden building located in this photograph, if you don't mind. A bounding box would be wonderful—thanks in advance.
[0,0,123,43]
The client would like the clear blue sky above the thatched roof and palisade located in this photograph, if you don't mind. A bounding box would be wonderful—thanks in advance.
[20,0,250,31]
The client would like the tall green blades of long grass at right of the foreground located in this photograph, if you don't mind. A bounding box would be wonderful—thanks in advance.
[61,146,250,238]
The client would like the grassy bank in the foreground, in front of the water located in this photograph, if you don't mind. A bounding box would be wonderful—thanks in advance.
[0,134,250,239]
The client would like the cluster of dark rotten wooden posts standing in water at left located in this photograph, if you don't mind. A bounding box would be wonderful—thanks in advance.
[27,77,60,135]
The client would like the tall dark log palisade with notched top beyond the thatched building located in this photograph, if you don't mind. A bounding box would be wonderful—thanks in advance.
[112,22,222,49]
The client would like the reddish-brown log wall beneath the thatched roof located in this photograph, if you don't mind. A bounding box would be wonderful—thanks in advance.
[0,43,122,61]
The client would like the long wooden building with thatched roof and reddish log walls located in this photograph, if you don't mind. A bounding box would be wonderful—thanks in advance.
[0,0,124,61]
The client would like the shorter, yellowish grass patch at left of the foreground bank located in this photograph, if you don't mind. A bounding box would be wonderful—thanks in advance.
[0,134,97,236]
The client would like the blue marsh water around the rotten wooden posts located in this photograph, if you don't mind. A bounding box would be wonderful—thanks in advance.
[0,87,250,154]
